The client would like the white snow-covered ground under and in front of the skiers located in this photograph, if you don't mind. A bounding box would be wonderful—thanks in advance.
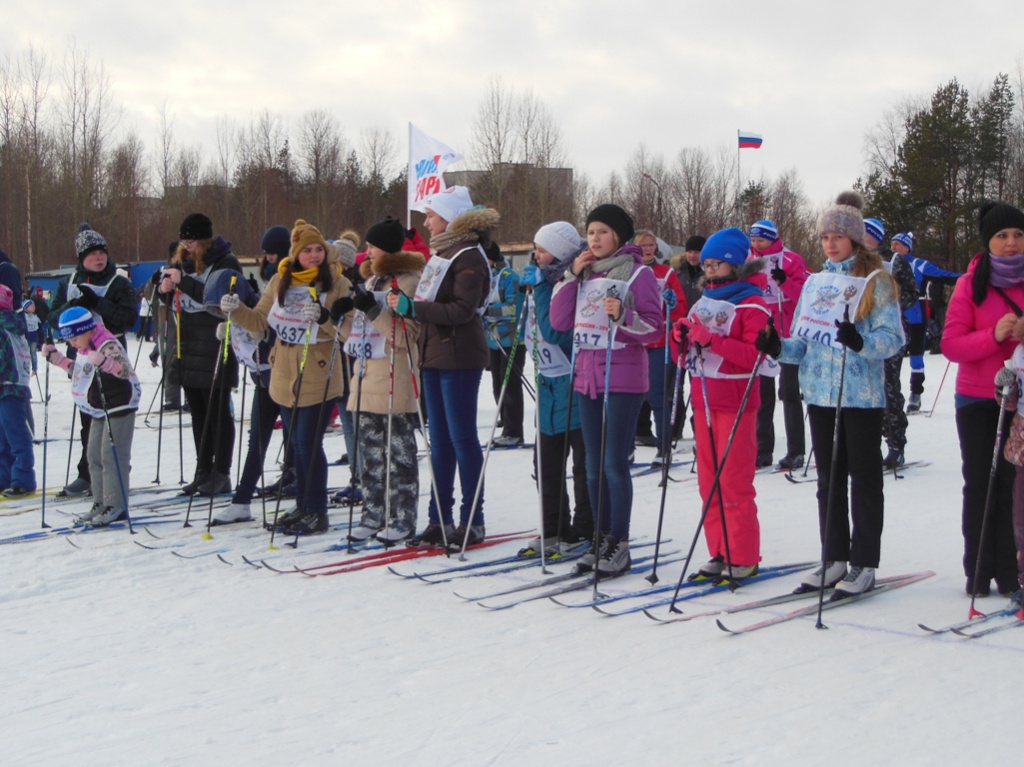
[0,342,1024,765]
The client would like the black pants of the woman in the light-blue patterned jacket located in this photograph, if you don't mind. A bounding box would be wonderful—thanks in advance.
[807,404,885,567]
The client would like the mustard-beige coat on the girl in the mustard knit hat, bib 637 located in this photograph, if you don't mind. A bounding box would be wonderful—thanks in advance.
[231,274,352,408]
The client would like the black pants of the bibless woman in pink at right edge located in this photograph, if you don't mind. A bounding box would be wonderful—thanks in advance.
[956,399,1017,592]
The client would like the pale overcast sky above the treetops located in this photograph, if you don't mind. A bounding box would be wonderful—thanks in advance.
[0,0,1024,209]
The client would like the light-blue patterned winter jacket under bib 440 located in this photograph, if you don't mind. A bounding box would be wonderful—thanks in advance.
[778,257,903,408]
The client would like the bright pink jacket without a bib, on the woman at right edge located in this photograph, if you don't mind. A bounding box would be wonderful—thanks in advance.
[942,254,1024,399]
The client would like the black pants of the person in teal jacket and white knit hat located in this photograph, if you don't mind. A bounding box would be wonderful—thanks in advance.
[534,429,594,540]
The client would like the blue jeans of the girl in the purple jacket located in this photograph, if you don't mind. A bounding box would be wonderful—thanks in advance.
[577,392,645,538]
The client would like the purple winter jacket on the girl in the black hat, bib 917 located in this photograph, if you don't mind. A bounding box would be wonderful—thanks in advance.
[551,245,665,399]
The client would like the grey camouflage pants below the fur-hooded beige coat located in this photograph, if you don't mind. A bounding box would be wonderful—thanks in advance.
[359,413,420,530]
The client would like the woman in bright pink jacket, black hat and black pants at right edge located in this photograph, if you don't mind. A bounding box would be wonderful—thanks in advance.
[942,203,1024,596]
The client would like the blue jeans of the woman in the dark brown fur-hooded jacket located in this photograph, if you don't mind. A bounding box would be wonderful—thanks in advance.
[422,368,487,525]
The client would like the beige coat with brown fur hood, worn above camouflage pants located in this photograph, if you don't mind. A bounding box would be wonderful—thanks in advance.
[341,251,426,415]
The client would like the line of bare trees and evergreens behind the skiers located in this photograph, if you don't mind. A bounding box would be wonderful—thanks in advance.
[0,40,1024,271]
